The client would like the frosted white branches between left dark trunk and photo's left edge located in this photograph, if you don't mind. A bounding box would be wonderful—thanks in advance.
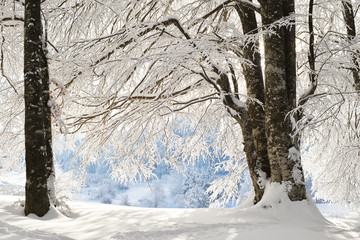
[0,1,24,170]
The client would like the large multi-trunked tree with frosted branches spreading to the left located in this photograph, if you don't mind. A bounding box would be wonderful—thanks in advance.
[50,0,306,203]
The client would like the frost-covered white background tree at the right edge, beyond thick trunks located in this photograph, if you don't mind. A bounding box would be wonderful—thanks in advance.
[304,1,360,205]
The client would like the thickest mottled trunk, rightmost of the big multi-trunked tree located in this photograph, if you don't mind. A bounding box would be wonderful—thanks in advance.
[261,0,306,201]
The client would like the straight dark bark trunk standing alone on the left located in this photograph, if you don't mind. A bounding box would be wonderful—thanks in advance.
[24,0,53,216]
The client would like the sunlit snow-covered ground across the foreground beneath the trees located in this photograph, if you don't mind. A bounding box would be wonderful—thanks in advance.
[0,195,360,240]
